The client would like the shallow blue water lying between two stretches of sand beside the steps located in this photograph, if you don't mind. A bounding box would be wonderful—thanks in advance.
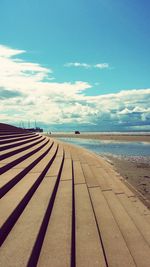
[59,137,150,157]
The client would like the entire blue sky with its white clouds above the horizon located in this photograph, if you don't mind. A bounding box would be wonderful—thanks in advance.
[0,0,150,131]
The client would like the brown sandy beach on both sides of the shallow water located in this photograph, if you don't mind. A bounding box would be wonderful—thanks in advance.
[52,133,150,207]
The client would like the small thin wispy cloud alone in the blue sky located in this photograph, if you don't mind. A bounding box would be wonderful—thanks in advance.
[64,62,109,69]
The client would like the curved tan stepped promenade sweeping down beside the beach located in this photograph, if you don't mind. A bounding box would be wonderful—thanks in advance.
[0,130,150,266]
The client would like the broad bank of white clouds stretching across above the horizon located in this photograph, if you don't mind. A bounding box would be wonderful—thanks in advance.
[0,44,150,131]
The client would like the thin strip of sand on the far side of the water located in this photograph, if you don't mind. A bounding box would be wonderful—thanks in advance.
[49,133,150,142]
